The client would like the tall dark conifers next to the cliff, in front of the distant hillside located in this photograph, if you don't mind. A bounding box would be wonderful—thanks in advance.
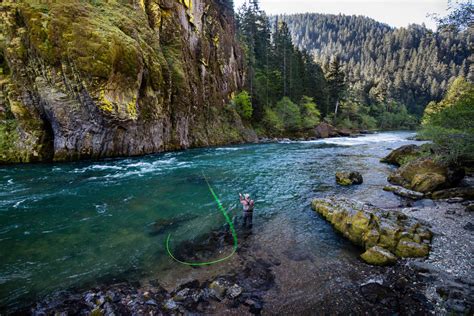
[237,1,329,133]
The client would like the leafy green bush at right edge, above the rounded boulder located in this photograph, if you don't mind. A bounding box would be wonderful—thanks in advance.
[420,78,474,163]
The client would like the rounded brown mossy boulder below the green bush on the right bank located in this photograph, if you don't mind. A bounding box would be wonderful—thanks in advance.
[388,157,464,193]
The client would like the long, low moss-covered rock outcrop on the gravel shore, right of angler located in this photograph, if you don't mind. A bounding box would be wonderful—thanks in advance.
[311,197,432,265]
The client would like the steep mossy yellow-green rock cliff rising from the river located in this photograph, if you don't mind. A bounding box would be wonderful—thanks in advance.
[0,0,254,163]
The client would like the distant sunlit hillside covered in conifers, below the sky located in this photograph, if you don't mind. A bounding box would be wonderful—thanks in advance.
[276,13,474,116]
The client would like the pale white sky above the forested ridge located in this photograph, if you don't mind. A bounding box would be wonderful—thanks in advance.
[234,0,447,30]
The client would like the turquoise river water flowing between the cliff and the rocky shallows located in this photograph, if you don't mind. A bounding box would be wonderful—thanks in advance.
[0,132,420,310]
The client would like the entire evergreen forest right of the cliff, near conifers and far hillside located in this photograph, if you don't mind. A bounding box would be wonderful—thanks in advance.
[232,0,474,135]
